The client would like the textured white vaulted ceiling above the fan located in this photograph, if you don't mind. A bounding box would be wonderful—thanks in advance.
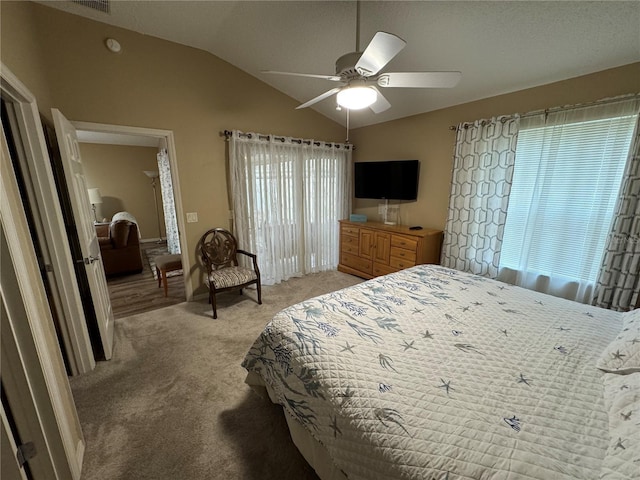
[38,0,640,128]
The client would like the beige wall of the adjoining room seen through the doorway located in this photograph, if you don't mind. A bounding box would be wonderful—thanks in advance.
[80,143,166,240]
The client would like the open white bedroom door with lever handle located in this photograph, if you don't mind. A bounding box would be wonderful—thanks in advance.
[51,108,113,360]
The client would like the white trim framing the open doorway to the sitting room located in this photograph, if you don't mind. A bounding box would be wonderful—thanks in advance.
[71,121,193,301]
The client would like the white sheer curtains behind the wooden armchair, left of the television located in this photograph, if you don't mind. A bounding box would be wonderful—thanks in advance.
[229,130,353,285]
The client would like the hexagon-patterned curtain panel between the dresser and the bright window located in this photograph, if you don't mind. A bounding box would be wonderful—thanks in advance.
[442,116,520,278]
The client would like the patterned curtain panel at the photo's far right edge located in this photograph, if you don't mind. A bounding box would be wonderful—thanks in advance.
[594,117,640,311]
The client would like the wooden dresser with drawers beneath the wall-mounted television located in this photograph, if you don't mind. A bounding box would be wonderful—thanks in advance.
[338,220,442,278]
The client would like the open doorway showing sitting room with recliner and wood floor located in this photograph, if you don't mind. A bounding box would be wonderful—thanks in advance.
[73,122,191,318]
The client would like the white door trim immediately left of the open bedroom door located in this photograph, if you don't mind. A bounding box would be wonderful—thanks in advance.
[0,63,95,375]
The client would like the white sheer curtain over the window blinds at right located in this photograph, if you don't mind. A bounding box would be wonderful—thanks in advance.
[498,96,638,303]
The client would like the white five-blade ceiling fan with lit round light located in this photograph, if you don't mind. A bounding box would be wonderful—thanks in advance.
[262,0,462,113]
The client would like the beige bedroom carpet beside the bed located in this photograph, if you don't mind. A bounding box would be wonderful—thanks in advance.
[71,272,361,480]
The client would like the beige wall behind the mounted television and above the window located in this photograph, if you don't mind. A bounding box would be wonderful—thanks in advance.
[351,63,640,229]
